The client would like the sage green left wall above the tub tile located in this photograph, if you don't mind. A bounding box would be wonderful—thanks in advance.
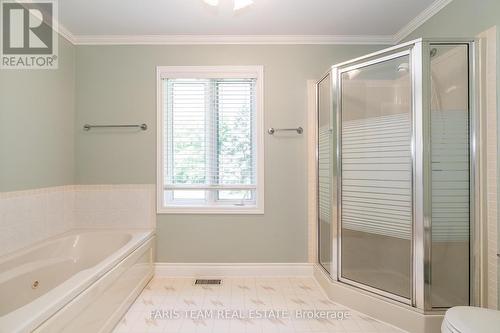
[0,38,75,192]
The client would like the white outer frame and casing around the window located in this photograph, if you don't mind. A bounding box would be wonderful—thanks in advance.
[156,66,264,214]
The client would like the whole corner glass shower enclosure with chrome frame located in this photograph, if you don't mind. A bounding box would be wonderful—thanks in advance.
[317,39,478,311]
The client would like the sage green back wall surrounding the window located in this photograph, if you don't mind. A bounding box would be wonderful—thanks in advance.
[76,45,382,262]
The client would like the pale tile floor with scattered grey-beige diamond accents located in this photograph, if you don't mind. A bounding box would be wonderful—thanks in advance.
[114,277,403,333]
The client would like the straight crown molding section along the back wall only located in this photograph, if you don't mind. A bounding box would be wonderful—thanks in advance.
[70,35,393,45]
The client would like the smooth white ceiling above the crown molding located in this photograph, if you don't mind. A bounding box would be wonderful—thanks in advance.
[59,0,451,44]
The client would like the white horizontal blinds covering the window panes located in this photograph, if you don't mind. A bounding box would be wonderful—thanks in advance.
[162,78,257,206]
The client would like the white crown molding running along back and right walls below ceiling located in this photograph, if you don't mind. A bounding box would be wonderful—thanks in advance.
[52,0,453,45]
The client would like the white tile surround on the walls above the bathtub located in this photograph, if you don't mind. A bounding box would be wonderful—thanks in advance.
[0,184,156,255]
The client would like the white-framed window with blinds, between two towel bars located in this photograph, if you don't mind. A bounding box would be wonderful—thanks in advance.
[157,66,264,214]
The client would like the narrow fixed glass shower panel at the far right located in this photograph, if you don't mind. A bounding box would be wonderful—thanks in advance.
[430,44,471,308]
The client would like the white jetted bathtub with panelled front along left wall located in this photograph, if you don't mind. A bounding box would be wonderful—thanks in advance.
[0,230,154,333]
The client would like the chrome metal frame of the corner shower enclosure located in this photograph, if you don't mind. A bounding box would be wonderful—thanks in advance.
[316,38,483,313]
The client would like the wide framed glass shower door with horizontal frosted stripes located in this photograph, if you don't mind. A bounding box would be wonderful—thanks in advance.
[338,52,413,302]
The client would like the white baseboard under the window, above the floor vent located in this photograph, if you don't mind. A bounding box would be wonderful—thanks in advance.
[155,263,314,277]
